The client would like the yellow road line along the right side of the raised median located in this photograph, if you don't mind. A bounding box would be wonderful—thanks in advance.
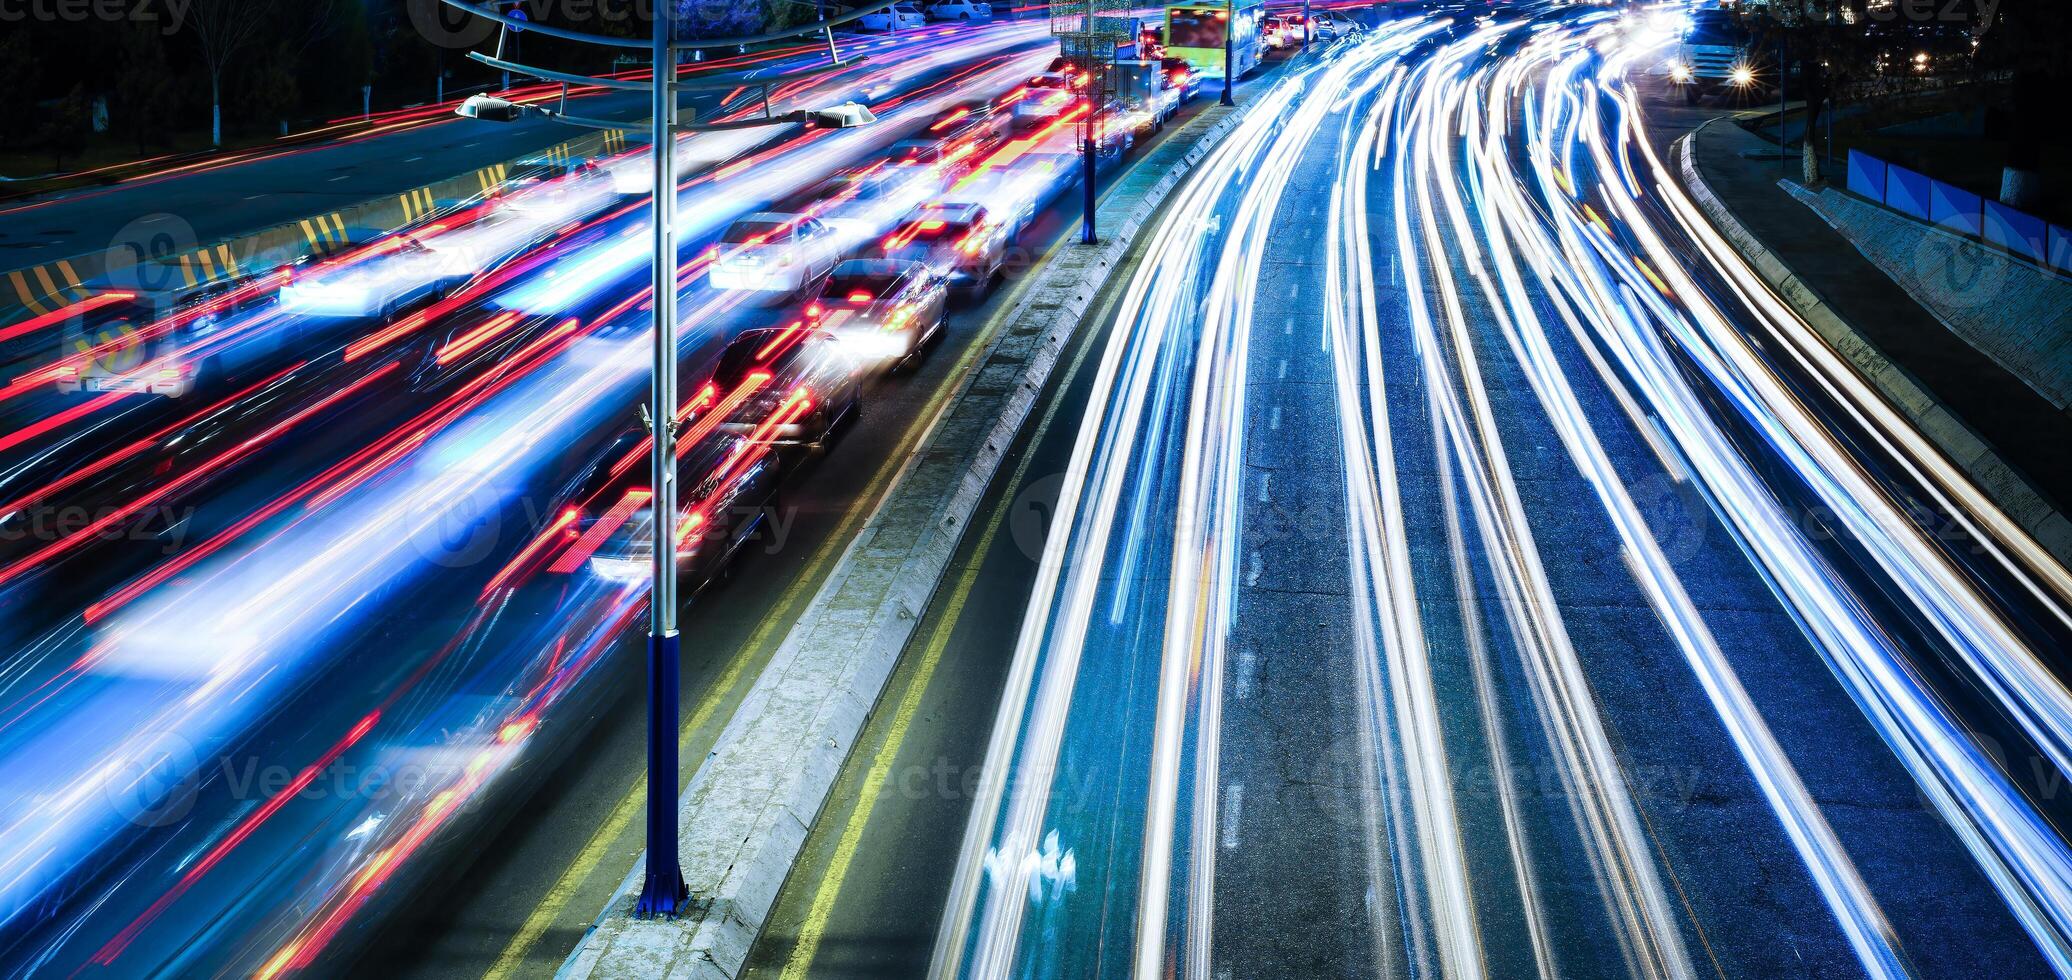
[781,219,1123,980]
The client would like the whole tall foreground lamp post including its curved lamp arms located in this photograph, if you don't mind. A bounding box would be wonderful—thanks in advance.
[441,0,895,918]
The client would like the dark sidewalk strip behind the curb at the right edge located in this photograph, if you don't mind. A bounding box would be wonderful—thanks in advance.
[1691,118,2072,530]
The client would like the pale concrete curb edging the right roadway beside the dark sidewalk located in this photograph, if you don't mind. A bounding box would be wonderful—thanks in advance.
[1678,116,2072,566]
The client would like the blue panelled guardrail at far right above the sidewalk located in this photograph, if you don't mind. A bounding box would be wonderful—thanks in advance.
[1848,149,2072,273]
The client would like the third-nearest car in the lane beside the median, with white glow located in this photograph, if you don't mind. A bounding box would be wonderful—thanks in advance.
[806,259,949,367]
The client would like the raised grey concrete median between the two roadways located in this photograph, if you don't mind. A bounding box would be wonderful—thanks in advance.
[557,106,1243,980]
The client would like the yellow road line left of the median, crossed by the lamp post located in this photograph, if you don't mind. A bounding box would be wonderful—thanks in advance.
[483,236,1069,980]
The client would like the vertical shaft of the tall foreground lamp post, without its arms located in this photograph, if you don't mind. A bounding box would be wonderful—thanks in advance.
[634,2,690,918]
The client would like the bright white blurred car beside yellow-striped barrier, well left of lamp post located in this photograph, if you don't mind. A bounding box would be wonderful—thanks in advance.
[280,234,481,319]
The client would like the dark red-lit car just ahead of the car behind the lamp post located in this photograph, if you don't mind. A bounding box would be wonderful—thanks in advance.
[698,327,864,454]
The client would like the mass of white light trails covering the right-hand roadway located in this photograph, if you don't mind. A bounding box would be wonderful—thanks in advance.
[930,10,2072,978]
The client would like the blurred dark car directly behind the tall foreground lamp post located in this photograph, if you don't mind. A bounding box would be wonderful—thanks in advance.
[553,426,783,595]
